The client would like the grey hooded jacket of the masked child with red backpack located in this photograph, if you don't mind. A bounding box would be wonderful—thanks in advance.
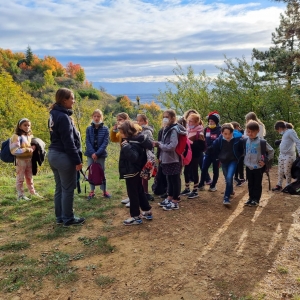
[158,123,187,164]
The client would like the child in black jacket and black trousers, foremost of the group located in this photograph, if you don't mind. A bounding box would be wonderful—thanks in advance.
[118,121,152,225]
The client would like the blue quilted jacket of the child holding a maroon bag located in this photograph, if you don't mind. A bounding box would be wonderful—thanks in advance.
[84,123,109,158]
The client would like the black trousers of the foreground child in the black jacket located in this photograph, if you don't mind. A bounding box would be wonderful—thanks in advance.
[125,174,151,217]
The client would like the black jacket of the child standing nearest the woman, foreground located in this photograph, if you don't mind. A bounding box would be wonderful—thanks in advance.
[119,134,153,179]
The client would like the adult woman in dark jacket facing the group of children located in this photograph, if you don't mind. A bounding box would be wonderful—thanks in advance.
[48,88,85,227]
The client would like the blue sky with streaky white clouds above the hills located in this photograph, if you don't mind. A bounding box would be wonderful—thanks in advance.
[0,0,285,94]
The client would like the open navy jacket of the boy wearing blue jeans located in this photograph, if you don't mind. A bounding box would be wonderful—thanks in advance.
[207,135,244,163]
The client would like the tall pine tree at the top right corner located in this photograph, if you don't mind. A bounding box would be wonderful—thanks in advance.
[253,0,300,88]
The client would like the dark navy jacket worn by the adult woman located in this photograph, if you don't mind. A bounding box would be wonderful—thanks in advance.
[49,104,81,165]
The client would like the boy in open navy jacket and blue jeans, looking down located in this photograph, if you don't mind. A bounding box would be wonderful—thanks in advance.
[208,123,243,206]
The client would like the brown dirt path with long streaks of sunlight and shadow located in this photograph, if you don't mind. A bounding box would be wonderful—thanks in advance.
[0,171,300,300]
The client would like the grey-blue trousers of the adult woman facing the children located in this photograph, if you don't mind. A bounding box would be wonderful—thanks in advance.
[48,149,77,223]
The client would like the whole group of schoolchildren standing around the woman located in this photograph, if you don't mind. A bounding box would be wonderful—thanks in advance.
[10,105,300,225]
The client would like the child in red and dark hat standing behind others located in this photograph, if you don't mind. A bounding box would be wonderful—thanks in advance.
[199,111,221,192]
